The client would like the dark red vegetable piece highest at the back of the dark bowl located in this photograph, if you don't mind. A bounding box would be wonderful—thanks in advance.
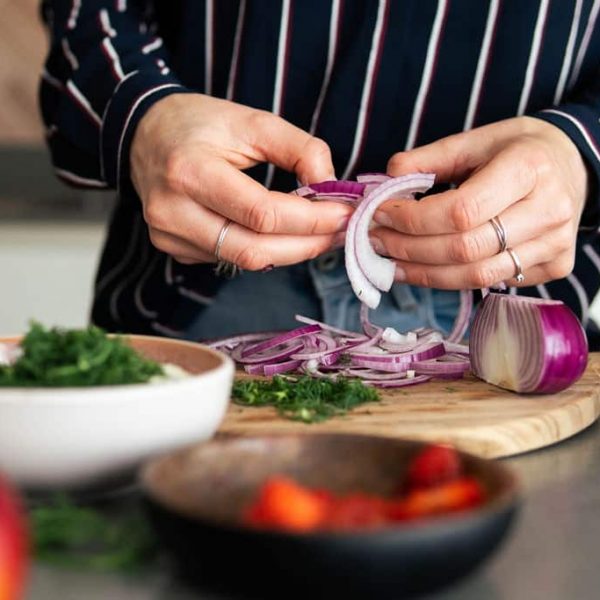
[406,445,462,490]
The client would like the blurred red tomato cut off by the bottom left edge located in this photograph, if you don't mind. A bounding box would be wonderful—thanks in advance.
[0,477,28,600]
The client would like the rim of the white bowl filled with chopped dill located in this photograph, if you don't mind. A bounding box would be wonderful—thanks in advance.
[0,333,235,404]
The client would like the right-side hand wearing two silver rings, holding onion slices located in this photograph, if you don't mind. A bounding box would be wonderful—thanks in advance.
[371,117,587,289]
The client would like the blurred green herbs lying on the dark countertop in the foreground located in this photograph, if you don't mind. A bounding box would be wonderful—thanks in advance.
[30,496,156,571]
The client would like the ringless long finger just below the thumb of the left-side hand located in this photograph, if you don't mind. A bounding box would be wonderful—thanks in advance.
[185,160,352,235]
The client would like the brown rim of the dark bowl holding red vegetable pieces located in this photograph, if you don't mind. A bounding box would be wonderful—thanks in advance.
[137,431,523,541]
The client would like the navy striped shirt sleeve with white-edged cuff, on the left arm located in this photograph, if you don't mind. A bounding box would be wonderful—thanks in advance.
[40,0,188,188]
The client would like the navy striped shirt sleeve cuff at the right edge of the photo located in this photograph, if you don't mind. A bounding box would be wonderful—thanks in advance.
[532,69,600,231]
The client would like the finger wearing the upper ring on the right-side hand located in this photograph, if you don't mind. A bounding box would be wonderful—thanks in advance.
[370,195,570,265]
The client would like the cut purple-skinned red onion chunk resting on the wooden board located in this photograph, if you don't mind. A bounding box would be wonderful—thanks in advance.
[469,294,588,394]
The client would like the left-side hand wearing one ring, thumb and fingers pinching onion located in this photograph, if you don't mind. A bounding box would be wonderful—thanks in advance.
[130,94,351,271]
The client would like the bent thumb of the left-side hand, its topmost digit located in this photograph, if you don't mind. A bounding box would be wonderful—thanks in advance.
[245,111,335,185]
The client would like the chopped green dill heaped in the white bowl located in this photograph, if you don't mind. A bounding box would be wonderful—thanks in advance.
[0,323,163,387]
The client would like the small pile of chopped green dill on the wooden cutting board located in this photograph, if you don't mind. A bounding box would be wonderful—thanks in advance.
[232,375,379,423]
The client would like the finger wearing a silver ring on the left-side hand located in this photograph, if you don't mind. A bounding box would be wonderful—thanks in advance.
[154,198,337,271]
